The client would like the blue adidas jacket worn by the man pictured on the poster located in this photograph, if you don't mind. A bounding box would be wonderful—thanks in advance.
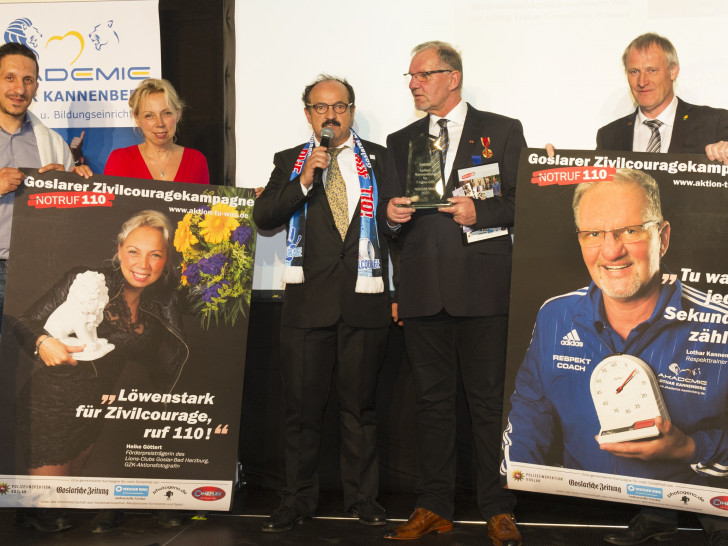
[503,281,728,487]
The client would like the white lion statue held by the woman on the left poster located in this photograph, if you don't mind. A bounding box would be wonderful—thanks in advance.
[45,271,114,360]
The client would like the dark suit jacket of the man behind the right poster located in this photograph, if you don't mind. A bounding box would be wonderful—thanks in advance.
[597,98,728,154]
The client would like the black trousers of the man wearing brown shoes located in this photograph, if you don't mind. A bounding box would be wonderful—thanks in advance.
[404,311,516,521]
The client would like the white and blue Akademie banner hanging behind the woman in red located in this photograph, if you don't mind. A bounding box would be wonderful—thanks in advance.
[0,0,162,172]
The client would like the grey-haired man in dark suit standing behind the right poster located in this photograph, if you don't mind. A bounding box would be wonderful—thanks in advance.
[597,33,728,546]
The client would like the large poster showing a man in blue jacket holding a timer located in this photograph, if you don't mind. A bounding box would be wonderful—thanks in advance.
[502,149,728,516]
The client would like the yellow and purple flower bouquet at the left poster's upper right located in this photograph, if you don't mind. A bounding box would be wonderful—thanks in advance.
[174,188,255,329]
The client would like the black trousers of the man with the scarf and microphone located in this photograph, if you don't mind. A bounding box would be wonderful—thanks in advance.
[281,321,389,515]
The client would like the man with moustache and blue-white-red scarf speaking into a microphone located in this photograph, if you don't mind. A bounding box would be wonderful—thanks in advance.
[253,75,391,532]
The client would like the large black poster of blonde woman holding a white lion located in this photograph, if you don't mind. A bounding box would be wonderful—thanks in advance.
[0,169,255,510]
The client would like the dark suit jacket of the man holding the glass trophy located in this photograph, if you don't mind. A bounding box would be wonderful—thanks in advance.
[378,105,526,318]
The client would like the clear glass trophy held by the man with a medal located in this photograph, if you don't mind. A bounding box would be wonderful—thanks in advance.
[398,134,452,209]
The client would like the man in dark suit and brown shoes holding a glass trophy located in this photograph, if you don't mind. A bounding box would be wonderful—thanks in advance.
[379,42,526,546]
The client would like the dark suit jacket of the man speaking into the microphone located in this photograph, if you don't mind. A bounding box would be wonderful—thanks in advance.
[253,140,392,328]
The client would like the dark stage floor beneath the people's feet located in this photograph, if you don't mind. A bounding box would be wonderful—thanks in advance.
[0,488,708,546]
